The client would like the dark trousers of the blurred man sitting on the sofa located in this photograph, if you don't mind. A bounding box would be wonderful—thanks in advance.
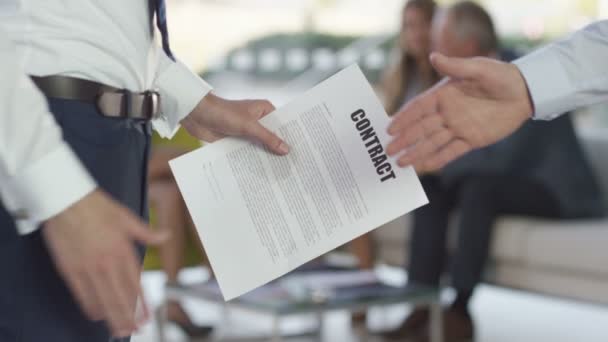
[409,175,560,293]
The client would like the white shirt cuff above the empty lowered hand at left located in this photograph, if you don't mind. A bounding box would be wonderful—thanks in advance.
[10,143,97,235]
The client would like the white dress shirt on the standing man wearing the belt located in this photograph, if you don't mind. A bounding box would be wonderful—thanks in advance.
[0,0,211,234]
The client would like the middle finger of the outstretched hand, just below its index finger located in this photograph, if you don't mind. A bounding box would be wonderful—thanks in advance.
[386,114,444,156]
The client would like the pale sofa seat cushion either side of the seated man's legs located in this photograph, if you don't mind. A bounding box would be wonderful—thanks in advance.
[374,217,608,275]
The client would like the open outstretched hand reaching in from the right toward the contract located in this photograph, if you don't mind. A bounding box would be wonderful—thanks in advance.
[387,53,533,172]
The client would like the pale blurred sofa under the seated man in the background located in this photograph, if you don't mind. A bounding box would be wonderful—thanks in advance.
[373,132,608,304]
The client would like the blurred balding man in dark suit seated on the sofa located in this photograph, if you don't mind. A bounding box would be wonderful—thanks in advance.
[384,1,604,342]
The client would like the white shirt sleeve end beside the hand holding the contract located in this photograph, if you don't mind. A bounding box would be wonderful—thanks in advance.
[152,48,212,138]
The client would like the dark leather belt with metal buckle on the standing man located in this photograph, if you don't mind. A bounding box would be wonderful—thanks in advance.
[31,75,160,120]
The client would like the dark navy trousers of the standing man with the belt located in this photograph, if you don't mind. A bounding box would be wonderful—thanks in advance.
[0,100,150,342]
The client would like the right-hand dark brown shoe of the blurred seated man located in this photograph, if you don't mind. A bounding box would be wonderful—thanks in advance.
[416,309,475,342]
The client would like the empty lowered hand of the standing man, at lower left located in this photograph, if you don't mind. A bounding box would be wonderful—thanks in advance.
[42,190,166,337]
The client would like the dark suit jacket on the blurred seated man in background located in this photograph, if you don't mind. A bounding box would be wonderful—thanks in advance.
[440,114,606,218]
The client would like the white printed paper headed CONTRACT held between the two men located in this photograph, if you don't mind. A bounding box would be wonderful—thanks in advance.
[170,65,428,300]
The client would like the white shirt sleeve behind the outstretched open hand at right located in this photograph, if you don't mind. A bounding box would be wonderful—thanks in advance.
[514,20,608,120]
